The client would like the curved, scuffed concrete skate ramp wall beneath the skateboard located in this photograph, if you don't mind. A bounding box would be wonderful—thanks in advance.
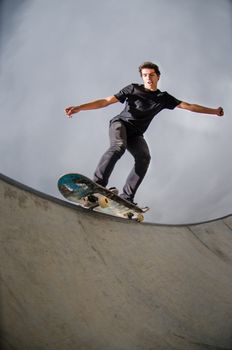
[0,176,232,350]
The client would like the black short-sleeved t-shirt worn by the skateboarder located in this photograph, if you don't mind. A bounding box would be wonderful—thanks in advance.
[111,84,181,135]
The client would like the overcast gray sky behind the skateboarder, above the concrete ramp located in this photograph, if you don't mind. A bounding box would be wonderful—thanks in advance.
[0,0,232,223]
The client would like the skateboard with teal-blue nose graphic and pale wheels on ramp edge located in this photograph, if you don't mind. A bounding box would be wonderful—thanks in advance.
[58,174,149,222]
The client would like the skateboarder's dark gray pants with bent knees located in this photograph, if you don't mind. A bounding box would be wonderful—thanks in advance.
[94,121,151,201]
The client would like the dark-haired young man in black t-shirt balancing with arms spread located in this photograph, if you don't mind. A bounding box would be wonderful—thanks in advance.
[65,62,224,203]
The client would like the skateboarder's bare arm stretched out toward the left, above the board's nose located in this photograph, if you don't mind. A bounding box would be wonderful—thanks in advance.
[64,96,119,118]
